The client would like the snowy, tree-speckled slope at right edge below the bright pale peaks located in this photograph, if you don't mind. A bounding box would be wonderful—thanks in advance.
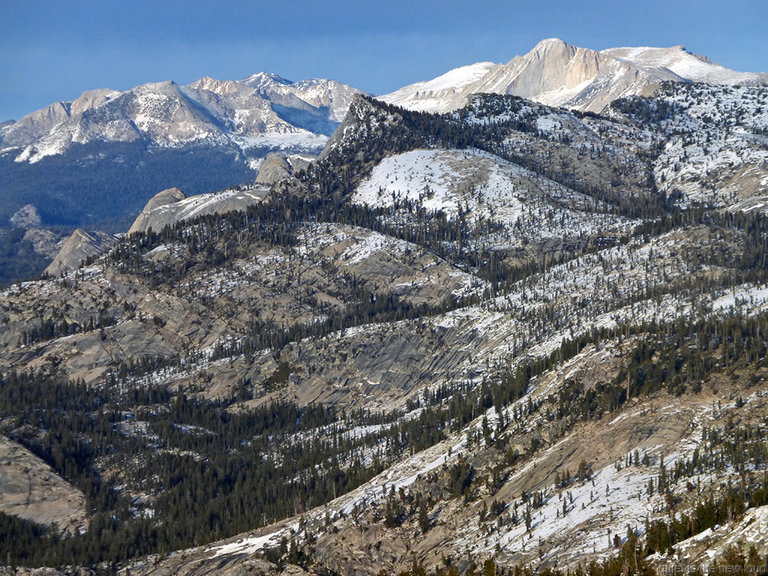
[612,84,768,210]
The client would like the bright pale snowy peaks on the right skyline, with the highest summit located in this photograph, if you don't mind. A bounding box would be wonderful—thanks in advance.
[381,38,768,112]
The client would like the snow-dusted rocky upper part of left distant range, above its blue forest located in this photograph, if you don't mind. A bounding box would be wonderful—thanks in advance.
[0,72,359,163]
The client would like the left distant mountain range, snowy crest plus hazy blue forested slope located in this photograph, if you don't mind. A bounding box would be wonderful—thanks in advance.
[0,73,359,230]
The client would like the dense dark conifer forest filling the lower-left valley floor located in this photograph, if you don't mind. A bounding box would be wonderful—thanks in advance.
[0,373,381,565]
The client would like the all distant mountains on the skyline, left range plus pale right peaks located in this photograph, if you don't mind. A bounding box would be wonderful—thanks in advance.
[0,39,768,284]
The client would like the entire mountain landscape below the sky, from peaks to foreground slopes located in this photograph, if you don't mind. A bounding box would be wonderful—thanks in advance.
[0,39,768,576]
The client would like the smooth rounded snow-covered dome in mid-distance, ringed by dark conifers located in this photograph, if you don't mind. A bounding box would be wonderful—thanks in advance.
[352,146,633,246]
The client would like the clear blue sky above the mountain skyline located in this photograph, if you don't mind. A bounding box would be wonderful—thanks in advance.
[0,0,768,120]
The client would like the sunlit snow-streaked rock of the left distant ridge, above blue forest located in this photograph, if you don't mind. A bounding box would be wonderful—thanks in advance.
[0,74,357,163]
